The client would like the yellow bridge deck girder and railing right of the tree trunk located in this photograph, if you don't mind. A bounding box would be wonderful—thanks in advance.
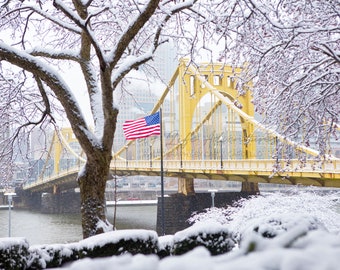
[107,159,340,188]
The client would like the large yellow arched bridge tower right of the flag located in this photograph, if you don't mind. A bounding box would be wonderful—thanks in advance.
[178,60,256,195]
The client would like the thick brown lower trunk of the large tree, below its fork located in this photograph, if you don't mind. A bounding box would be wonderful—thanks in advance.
[78,155,111,239]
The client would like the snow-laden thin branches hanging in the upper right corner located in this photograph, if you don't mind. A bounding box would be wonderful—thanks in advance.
[213,0,340,158]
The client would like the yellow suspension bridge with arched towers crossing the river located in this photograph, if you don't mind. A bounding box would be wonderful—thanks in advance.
[24,60,340,194]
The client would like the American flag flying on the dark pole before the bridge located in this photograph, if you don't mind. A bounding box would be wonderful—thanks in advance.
[123,112,161,140]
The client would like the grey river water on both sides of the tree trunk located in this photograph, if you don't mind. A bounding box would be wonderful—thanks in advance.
[0,205,157,245]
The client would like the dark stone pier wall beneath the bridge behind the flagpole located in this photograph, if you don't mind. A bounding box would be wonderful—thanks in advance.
[156,192,252,235]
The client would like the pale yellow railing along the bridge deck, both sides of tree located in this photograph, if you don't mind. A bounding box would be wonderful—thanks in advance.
[24,159,340,189]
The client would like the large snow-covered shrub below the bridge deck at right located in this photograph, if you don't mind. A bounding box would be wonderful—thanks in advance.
[189,187,340,253]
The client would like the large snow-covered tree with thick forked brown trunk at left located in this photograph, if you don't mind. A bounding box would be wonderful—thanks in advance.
[0,0,203,238]
